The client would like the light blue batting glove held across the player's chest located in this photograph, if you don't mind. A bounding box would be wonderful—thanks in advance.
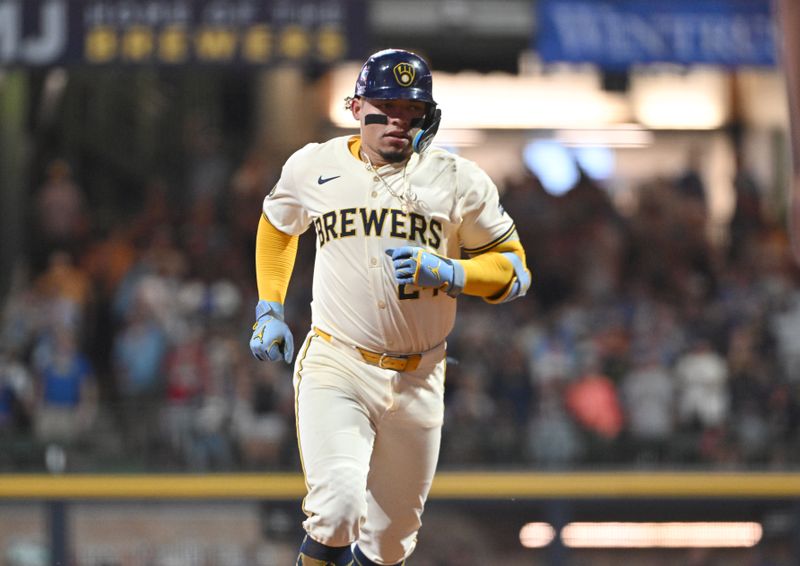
[386,246,465,297]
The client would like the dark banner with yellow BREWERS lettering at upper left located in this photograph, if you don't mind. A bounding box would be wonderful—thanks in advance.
[0,0,366,67]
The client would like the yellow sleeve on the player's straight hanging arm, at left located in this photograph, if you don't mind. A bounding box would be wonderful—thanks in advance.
[256,213,300,304]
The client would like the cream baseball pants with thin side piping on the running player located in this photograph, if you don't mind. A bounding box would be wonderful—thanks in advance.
[294,331,445,564]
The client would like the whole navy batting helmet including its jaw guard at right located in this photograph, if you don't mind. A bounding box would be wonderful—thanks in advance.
[354,49,442,153]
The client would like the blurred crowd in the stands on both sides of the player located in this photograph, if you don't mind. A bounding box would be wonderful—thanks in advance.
[0,140,800,472]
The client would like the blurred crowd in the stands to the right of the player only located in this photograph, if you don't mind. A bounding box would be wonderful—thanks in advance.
[443,160,800,469]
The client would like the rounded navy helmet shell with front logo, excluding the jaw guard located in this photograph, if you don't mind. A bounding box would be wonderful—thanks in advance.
[355,49,436,105]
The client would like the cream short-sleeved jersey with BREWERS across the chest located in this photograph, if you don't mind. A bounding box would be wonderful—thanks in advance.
[263,136,514,354]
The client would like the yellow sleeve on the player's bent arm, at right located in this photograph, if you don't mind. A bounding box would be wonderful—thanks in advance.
[458,240,525,298]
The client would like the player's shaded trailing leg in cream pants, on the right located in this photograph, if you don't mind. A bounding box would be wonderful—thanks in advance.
[354,361,444,566]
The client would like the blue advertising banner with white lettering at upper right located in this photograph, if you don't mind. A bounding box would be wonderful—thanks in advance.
[532,0,776,70]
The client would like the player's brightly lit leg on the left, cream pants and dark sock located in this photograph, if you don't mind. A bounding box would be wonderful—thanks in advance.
[295,336,384,566]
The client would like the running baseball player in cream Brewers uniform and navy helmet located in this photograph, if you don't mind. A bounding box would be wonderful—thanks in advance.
[250,49,531,566]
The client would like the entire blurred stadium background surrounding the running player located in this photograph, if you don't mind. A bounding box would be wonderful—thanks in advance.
[0,0,800,566]
